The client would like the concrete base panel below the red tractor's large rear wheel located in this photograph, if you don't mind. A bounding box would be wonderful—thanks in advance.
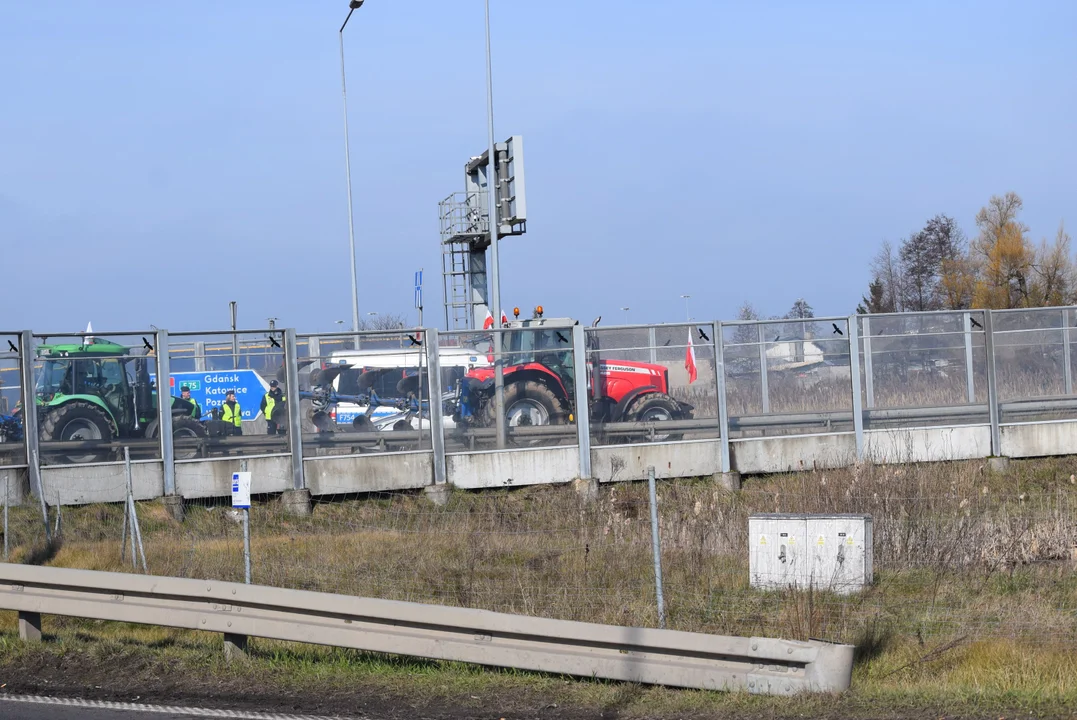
[445,446,579,490]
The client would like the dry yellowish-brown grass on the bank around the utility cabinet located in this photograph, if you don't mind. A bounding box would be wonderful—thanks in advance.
[5,458,1077,716]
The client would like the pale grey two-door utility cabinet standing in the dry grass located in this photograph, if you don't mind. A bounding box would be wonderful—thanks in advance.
[747,513,873,594]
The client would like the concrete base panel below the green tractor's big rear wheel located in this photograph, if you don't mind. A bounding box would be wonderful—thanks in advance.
[41,461,162,505]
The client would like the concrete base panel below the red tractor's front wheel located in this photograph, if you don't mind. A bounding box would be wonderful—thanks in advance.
[591,440,722,482]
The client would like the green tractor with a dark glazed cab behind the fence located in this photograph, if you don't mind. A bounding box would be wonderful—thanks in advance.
[36,338,206,463]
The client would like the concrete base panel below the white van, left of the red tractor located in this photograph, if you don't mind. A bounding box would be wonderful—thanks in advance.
[303,450,434,496]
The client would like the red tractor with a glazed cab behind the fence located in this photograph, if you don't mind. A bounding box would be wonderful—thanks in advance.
[453,316,693,439]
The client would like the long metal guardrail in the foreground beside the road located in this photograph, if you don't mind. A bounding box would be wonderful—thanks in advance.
[0,564,853,694]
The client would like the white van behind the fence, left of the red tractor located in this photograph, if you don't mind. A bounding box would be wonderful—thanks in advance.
[330,347,491,429]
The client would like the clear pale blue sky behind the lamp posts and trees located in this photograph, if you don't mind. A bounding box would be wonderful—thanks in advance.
[0,0,1077,331]
